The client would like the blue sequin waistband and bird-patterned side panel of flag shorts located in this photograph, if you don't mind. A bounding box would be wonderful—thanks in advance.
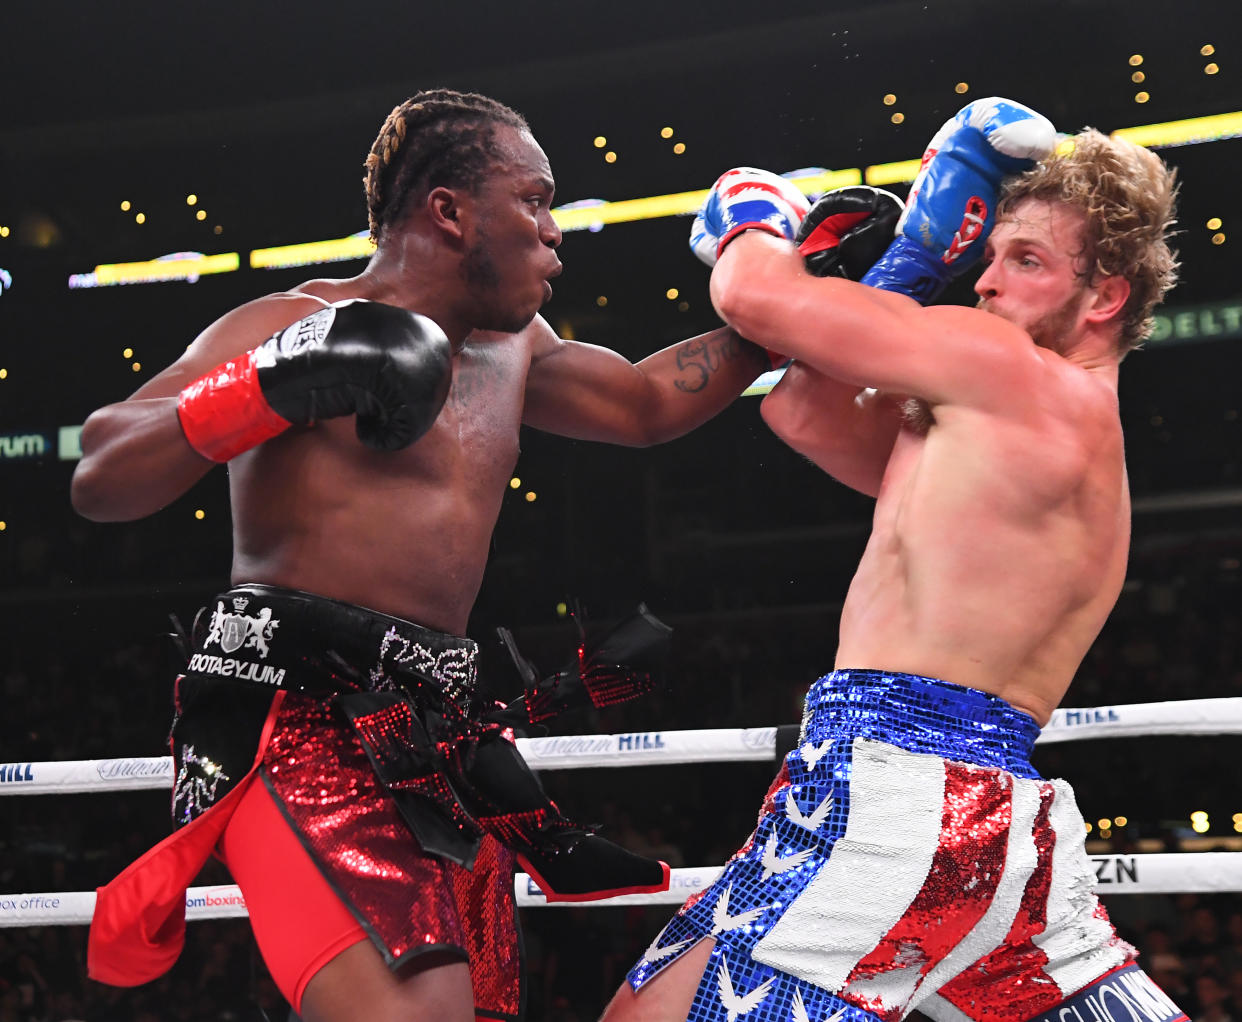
[628,671,1040,1022]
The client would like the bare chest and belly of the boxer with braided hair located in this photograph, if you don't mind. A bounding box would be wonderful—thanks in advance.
[229,282,535,635]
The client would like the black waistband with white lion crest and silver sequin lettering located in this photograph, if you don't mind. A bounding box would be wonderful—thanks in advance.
[189,584,478,699]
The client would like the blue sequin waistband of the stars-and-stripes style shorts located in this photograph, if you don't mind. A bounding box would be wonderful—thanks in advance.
[802,669,1040,777]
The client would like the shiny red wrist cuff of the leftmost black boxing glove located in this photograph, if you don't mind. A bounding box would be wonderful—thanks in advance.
[176,351,292,462]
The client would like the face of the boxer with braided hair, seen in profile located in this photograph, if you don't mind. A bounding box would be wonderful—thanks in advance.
[462,125,561,333]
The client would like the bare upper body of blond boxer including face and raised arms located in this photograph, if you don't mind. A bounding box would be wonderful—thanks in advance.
[713,200,1130,724]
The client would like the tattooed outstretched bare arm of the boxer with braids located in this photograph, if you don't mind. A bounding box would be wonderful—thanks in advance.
[523,319,770,447]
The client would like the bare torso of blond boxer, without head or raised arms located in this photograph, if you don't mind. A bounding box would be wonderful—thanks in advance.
[764,342,1130,724]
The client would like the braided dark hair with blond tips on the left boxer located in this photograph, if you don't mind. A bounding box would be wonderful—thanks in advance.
[363,88,529,243]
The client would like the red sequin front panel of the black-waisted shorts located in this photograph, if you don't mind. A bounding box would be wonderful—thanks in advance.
[263,693,520,1016]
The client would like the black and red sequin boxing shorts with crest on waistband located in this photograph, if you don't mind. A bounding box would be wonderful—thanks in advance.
[171,585,522,1018]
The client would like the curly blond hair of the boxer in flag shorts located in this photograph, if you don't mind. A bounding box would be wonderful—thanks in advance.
[996,128,1177,353]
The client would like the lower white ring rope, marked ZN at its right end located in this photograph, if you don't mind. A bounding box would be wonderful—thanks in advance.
[7,852,1242,928]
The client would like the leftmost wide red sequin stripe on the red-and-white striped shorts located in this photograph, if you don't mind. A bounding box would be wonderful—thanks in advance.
[843,762,1013,1022]
